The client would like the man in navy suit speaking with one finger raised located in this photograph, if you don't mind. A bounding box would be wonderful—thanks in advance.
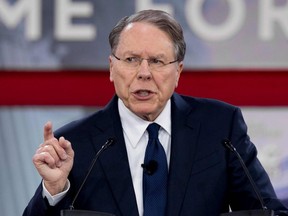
[23,10,286,216]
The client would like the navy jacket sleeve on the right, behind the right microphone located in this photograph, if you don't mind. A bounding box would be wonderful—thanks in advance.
[227,108,285,210]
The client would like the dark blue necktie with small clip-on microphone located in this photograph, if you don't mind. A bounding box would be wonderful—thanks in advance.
[143,123,168,216]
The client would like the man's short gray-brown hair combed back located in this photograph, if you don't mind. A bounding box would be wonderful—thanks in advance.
[109,10,186,62]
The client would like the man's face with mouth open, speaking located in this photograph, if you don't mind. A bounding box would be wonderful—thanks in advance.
[109,22,183,121]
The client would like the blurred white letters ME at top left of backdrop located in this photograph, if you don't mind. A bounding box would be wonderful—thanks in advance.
[0,0,96,41]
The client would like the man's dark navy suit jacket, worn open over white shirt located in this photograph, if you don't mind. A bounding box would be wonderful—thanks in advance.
[23,93,285,216]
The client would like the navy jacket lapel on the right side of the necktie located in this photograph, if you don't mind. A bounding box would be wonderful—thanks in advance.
[167,94,199,216]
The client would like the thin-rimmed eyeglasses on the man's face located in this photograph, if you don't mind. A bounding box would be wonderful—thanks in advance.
[112,53,178,71]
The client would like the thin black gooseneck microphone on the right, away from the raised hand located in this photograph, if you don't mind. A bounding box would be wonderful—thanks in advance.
[220,139,274,216]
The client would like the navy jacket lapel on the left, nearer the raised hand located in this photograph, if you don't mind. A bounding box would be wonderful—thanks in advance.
[90,96,139,216]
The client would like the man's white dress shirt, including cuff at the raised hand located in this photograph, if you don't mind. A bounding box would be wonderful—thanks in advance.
[42,99,171,216]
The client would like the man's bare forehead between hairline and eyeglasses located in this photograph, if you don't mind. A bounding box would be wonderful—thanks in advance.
[117,22,174,55]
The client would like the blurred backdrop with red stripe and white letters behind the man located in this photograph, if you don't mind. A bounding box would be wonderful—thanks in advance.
[0,0,288,216]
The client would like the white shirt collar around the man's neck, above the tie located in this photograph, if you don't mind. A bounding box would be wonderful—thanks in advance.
[118,98,171,147]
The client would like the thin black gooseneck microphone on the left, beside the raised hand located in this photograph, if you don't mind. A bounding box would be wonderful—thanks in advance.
[61,138,116,216]
